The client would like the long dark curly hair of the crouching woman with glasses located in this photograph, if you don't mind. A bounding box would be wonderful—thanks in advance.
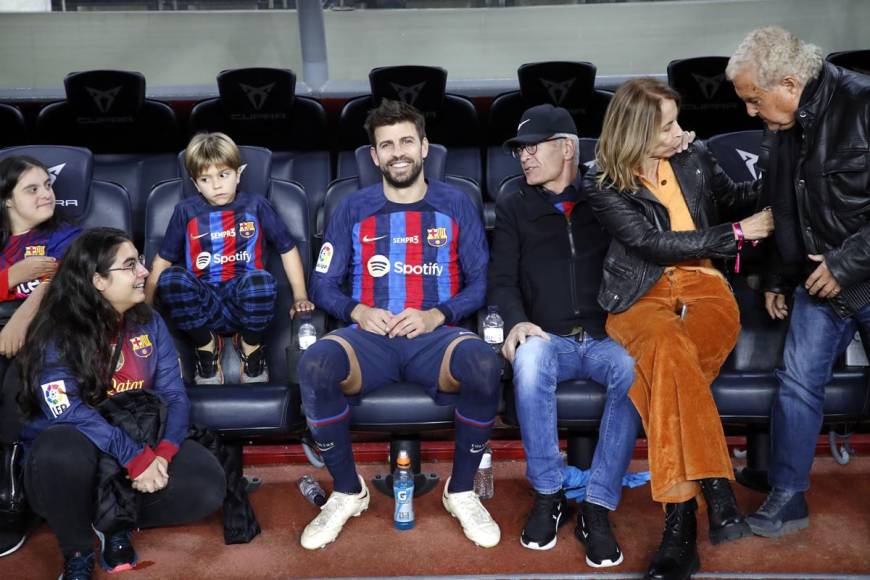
[17,228,152,417]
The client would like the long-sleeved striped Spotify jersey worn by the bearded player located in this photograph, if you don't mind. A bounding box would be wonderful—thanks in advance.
[311,181,489,322]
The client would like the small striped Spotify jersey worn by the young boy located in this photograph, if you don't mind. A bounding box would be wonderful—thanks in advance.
[159,192,296,284]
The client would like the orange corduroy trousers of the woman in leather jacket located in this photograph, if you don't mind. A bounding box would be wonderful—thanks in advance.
[607,268,740,503]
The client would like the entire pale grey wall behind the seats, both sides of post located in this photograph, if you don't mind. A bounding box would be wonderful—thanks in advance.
[0,0,870,88]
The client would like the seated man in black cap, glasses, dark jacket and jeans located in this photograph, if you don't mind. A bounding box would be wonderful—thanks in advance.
[488,105,639,568]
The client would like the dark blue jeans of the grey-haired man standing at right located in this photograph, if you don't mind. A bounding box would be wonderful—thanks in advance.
[767,286,870,491]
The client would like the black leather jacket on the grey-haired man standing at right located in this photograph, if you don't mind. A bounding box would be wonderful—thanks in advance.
[768,62,870,315]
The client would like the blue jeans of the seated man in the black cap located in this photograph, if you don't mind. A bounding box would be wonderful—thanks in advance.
[513,334,640,510]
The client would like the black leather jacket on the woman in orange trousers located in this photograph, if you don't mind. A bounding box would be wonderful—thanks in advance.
[585,143,760,312]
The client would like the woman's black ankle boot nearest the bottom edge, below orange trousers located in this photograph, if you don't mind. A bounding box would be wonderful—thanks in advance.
[645,499,701,580]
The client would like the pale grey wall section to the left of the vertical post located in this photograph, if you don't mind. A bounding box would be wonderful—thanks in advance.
[0,10,302,88]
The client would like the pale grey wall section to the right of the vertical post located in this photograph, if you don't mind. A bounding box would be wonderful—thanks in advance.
[326,0,870,79]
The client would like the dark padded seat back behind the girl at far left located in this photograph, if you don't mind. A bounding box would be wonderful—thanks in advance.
[0,145,132,234]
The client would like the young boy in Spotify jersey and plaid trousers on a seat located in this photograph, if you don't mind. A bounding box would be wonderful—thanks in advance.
[145,133,314,384]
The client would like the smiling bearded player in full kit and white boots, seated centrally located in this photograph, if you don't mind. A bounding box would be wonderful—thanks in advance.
[299,100,501,550]
